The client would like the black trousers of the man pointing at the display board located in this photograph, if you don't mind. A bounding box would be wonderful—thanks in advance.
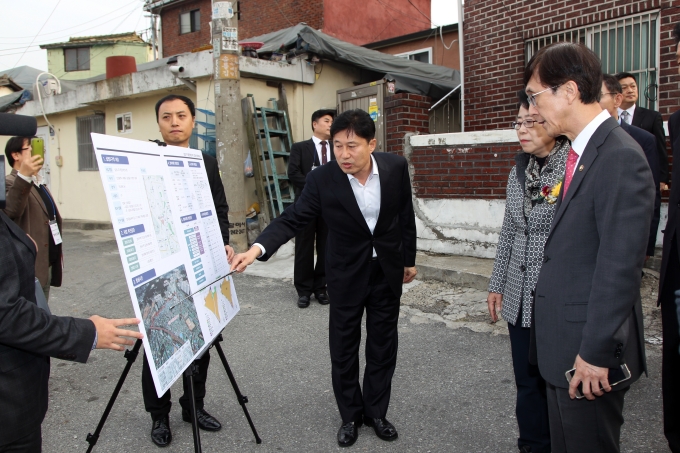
[329,261,399,423]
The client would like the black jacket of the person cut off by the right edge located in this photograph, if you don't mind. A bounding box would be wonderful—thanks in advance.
[659,110,680,303]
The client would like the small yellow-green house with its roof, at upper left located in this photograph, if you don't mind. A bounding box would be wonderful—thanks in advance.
[40,33,152,80]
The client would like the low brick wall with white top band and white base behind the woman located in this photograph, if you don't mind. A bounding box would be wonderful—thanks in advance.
[403,130,668,258]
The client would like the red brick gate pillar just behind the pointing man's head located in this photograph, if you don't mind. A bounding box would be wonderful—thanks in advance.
[384,93,432,154]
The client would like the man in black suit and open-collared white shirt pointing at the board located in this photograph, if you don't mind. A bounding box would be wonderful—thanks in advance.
[231,109,417,447]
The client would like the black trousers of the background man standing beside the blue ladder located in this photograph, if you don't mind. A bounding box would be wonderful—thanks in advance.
[293,217,328,296]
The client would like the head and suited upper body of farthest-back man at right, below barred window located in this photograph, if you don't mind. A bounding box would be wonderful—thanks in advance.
[616,72,670,190]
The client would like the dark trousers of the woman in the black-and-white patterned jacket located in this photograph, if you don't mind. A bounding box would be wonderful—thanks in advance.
[508,320,550,453]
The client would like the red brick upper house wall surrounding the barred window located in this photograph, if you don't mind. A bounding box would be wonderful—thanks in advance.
[464,0,680,131]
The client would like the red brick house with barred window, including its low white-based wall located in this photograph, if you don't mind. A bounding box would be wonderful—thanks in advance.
[394,0,680,258]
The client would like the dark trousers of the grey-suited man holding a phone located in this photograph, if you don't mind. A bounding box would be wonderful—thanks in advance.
[546,383,628,453]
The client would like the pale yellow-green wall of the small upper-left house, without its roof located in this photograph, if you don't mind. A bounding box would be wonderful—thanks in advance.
[47,42,152,80]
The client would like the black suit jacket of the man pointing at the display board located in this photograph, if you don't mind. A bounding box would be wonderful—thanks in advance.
[255,152,416,303]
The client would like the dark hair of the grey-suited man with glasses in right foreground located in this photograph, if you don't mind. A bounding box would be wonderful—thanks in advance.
[524,42,602,104]
